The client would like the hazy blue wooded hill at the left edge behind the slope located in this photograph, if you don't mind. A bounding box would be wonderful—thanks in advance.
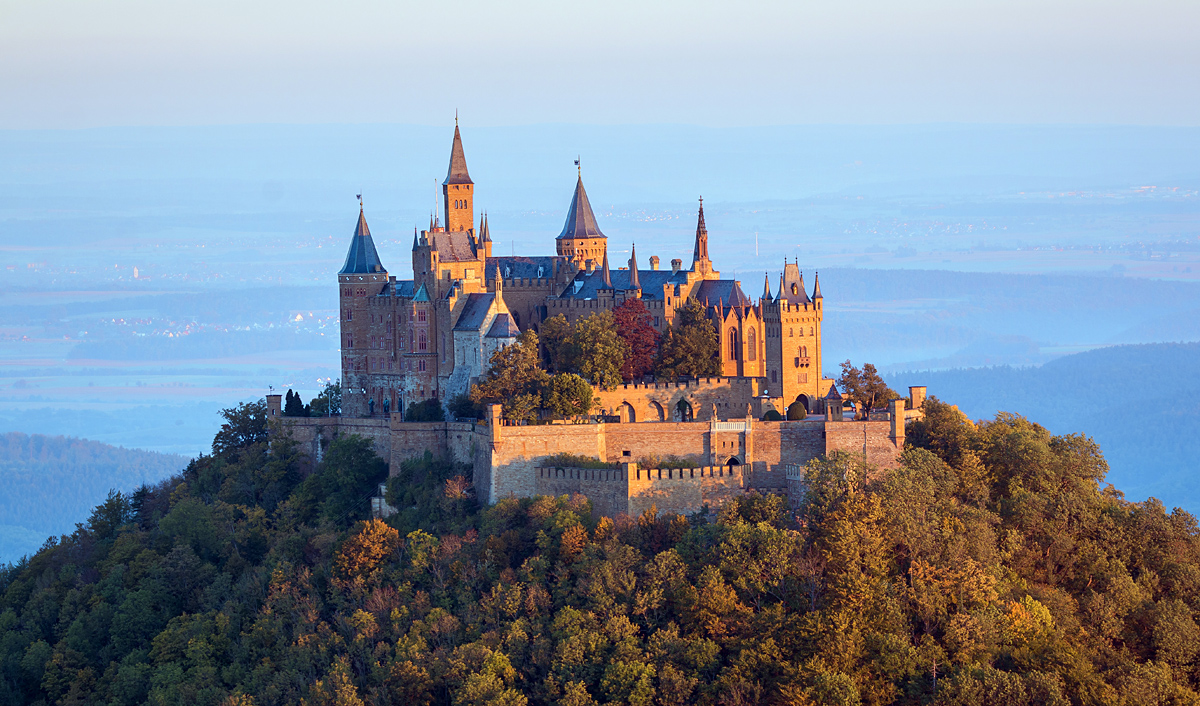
[0,432,187,561]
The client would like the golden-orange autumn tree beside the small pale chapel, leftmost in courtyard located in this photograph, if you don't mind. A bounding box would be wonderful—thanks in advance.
[470,329,550,420]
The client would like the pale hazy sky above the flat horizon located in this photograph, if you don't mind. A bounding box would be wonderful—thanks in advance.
[0,0,1200,127]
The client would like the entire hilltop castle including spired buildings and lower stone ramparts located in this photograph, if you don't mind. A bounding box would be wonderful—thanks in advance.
[268,124,925,515]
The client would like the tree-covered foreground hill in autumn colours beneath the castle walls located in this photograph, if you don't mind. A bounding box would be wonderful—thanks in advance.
[0,399,1200,706]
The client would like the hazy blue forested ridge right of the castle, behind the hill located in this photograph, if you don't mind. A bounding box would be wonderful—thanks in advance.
[888,343,1200,514]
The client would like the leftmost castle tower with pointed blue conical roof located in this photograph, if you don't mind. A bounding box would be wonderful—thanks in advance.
[337,204,388,414]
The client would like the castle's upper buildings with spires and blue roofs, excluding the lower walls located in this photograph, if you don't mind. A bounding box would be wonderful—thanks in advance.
[337,125,832,420]
